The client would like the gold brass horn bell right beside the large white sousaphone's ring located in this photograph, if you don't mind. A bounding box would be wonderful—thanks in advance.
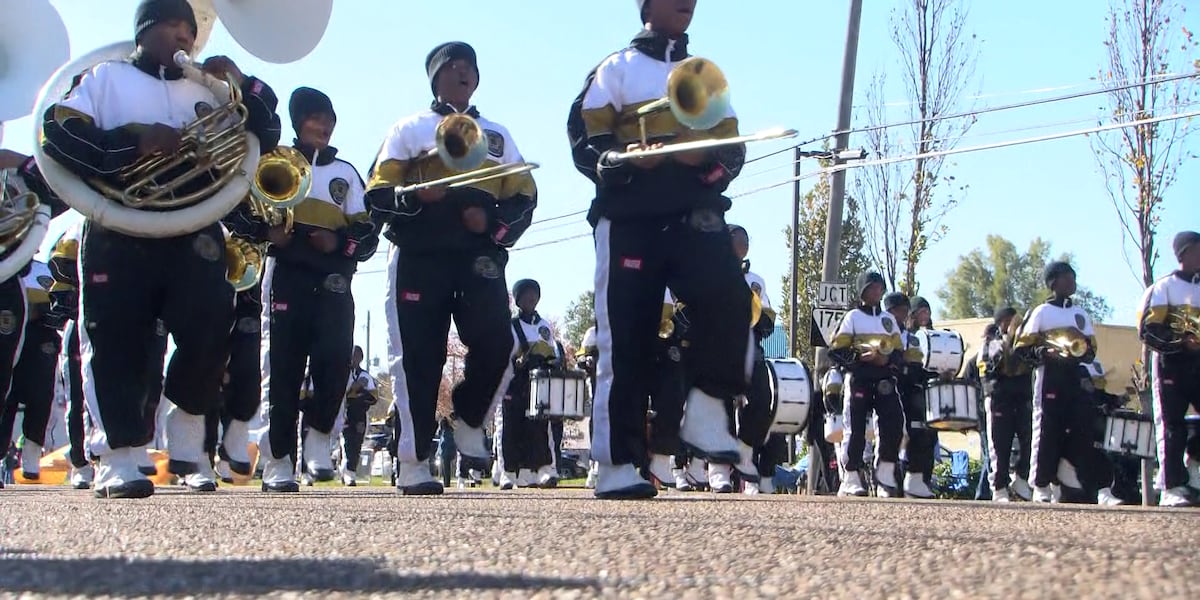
[246,146,312,233]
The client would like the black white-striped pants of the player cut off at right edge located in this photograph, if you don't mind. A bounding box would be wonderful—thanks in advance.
[1152,353,1200,490]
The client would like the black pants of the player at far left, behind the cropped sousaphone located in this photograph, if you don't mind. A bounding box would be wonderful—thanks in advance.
[0,320,62,446]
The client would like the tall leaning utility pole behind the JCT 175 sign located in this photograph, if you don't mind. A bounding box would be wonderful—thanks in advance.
[793,0,863,494]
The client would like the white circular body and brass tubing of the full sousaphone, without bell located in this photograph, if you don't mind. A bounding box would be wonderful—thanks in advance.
[34,42,259,238]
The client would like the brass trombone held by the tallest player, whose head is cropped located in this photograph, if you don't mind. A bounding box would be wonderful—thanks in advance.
[611,56,798,162]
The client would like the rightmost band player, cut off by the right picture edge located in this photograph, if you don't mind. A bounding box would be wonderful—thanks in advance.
[1138,232,1200,506]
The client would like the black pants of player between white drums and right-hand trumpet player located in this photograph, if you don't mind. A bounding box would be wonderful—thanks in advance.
[984,379,1033,490]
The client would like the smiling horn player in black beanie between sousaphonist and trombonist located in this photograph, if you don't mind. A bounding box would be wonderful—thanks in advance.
[227,88,379,492]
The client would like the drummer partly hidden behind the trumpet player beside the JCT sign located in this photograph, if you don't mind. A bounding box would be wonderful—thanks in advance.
[883,292,937,499]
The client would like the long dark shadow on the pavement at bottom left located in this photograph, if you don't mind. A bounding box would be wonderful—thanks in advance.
[0,550,599,595]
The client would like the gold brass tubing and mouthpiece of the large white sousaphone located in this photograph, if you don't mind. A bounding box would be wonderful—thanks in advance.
[91,50,250,209]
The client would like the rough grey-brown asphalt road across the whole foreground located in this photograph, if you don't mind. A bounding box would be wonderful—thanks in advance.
[0,486,1200,600]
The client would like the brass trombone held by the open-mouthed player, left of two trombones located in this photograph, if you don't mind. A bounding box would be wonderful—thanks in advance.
[396,113,540,194]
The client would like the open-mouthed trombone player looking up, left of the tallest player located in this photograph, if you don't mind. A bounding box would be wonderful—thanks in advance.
[367,42,536,494]
